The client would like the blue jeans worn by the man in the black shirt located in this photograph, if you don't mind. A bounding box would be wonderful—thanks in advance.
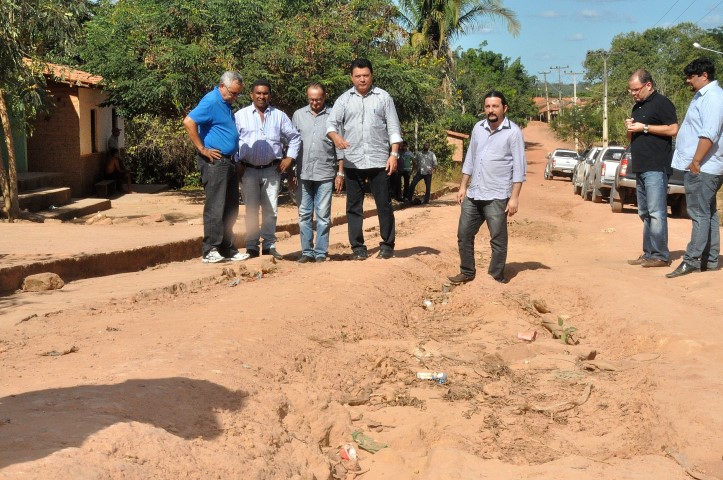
[635,172,670,262]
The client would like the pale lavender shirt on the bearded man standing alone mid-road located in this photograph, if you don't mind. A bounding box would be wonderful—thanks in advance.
[462,118,527,200]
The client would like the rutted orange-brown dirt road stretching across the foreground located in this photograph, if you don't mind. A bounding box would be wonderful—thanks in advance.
[0,123,723,480]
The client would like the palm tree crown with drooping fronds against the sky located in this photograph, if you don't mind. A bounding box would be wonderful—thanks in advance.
[399,0,520,58]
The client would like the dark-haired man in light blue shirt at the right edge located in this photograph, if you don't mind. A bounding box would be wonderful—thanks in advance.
[666,58,723,278]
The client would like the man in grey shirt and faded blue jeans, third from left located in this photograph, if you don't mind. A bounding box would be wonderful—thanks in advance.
[291,82,344,263]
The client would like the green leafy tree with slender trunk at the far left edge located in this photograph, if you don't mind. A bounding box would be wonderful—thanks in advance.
[0,0,88,222]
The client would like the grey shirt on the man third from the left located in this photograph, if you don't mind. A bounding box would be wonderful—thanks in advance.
[291,105,337,181]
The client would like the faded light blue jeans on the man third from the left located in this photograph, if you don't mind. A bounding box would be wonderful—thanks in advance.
[299,178,334,258]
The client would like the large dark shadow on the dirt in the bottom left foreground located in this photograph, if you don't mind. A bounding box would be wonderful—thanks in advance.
[0,377,248,468]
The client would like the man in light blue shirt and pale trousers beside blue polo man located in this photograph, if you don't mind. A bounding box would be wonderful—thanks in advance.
[234,79,301,260]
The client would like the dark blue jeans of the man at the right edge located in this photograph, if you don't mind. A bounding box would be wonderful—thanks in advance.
[683,172,723,270]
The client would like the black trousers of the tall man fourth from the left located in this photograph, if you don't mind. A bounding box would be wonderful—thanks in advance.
[344,168,396,253]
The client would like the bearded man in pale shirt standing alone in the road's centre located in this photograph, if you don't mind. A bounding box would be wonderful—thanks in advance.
[449,90,527,284]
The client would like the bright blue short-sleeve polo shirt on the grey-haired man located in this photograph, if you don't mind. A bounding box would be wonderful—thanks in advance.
[188,87,238,155]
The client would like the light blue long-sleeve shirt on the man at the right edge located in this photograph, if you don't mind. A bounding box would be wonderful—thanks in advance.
[673,80,723,175]
